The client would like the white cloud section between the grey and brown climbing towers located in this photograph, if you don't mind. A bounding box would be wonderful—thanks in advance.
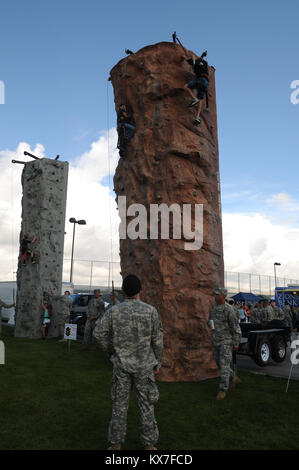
[64,129,120,284]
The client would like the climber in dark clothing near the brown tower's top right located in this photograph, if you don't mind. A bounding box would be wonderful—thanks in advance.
[184,49,209,126]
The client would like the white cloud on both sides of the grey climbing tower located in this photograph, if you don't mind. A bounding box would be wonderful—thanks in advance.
[0,129,120,284]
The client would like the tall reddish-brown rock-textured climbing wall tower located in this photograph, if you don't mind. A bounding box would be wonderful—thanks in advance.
[111,42,224,381]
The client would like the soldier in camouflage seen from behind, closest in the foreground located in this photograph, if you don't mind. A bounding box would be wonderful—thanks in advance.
[94,275,163,450]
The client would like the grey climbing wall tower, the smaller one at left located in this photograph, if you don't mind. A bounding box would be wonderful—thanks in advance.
[15,158,68,338]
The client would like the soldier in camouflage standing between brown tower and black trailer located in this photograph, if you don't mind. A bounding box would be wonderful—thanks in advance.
[208,288,242,400]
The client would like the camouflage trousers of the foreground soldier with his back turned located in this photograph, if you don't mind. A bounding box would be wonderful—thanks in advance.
[108,367,159,446]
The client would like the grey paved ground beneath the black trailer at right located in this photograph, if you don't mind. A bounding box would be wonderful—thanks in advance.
[237,335,299,380]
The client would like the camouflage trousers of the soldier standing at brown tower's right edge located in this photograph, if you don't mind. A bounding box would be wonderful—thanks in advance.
[212,343,235,392]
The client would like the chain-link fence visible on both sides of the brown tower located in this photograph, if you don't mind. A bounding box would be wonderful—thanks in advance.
[63,259,299,296]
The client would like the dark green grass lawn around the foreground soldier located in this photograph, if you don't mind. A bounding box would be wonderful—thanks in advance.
[0,327,299,450]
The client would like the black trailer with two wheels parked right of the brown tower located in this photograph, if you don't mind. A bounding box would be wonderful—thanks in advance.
[237,320,291,367]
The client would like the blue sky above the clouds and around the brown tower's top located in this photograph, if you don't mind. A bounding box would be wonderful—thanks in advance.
[0,0,299,280]
